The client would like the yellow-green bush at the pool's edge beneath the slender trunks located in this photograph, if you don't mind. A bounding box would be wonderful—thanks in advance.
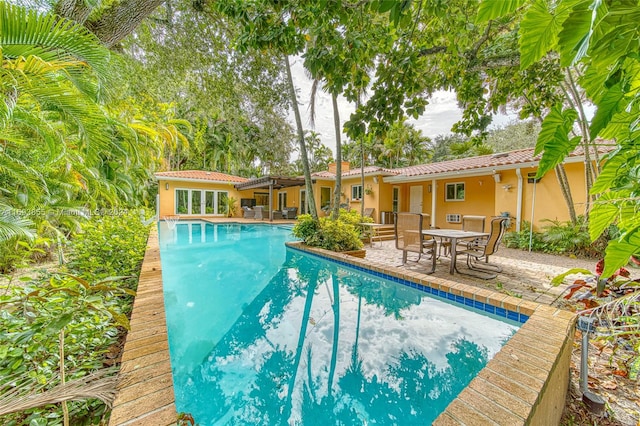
[293,210,371,251]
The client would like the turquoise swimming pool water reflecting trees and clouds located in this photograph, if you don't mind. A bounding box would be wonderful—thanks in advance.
[160,222,519,425]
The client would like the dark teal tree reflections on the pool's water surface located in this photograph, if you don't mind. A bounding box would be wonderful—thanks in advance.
[182,251,487,424]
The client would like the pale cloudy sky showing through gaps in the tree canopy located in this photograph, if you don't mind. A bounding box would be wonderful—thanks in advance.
[289,58,516,152]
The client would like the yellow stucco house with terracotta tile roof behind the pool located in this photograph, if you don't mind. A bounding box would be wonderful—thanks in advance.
[155,149,600,230]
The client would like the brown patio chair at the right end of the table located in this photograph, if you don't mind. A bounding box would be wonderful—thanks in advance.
[455,217,508,280]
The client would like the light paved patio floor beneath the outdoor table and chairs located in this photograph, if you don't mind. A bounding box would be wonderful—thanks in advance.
[365,241,596,307]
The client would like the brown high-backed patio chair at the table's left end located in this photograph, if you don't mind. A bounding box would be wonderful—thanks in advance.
[394,213,437,274]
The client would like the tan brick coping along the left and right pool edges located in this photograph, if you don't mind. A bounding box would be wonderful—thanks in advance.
[109,226,575,426]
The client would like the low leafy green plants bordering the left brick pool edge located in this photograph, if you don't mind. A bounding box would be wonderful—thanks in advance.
[0,211,149,425]
